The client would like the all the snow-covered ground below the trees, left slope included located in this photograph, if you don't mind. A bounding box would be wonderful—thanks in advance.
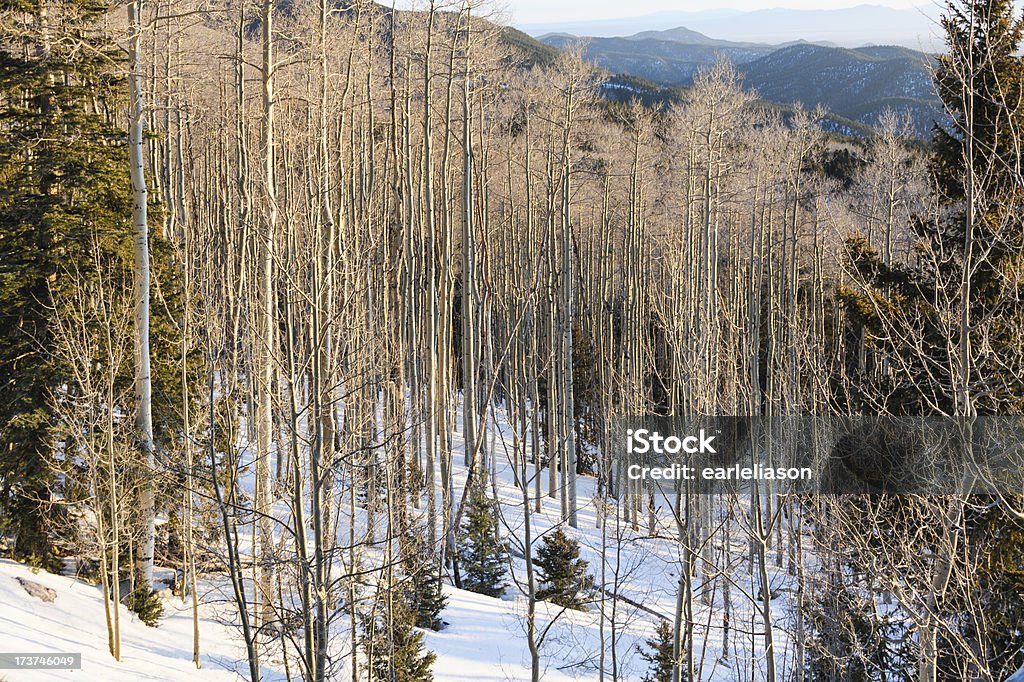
[0,399,793,682]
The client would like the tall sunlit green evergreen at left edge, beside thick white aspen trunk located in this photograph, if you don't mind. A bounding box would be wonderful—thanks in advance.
[0,0,131,566]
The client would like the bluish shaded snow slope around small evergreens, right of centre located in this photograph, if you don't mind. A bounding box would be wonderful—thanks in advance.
[415,408,793,682]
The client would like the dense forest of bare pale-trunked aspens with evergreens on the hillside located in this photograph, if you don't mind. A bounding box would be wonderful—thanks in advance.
[0,0,1024,682]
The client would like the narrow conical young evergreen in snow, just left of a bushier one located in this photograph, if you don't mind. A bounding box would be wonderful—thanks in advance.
[459,485,507,597]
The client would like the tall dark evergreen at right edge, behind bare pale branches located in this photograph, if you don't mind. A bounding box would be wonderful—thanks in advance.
[841,0,1024,679]
